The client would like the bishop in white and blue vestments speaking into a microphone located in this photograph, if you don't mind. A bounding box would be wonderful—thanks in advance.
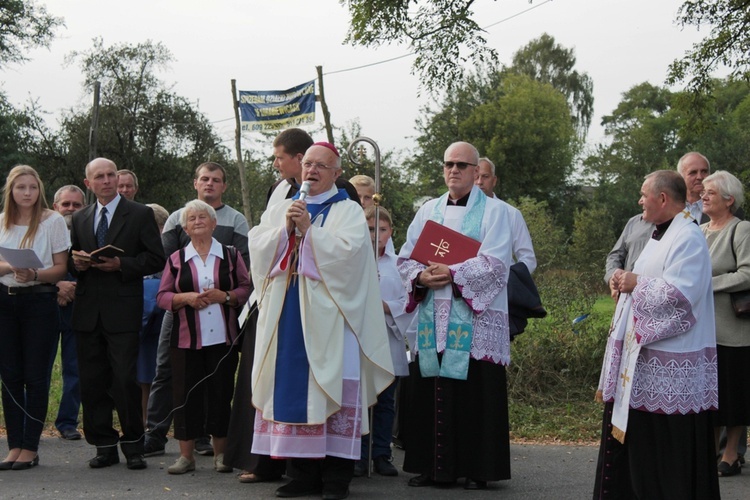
[249,143,393,498]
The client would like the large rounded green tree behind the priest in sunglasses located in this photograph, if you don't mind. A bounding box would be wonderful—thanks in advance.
[406,72,579,215]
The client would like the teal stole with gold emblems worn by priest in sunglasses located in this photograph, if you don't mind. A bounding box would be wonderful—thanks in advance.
[417,193,487,380]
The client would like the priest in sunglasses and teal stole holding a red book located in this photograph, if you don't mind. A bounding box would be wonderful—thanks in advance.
[399,142,513,489]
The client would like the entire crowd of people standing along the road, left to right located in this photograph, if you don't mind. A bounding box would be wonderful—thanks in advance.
[0,129,750,499]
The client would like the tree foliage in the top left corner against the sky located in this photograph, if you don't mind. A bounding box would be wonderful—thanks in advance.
[0,0,63,66]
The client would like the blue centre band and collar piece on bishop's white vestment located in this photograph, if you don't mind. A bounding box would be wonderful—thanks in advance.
[273,189,349,424]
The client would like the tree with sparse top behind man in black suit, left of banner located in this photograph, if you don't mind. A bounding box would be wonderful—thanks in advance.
[61,39,228,210]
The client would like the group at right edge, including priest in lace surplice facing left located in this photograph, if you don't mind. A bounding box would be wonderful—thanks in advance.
[594,152,750,499]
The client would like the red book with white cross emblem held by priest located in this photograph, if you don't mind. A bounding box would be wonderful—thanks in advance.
[411,220,482,266]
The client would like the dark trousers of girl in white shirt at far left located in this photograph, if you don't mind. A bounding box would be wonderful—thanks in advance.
[0,287,59,451]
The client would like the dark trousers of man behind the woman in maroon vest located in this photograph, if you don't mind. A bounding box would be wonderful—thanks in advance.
[146,311,174,446]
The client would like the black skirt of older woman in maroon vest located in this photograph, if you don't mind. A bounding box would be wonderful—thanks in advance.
[170,344,238,441]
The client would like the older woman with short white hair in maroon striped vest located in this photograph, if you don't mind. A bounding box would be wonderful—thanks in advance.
[156,200,250,474]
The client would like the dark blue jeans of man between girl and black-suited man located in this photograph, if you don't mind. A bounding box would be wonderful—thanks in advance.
[50,304,81,432]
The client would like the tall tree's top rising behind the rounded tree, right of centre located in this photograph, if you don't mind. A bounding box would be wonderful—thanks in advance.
[508,33,594,137]
